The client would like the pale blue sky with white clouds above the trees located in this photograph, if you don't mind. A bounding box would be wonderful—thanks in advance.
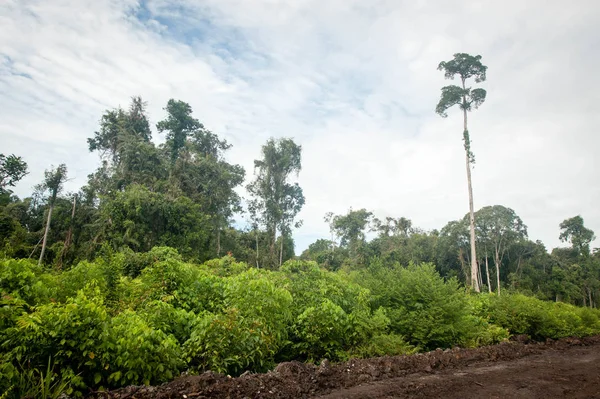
[0,0,600,252]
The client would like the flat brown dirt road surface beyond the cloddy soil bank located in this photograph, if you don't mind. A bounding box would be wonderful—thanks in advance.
[319,345,600,399]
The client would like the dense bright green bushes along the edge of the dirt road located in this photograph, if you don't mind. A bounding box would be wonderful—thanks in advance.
[0,247,600,399]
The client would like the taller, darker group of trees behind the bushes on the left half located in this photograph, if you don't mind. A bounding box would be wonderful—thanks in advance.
[0,97,304,269]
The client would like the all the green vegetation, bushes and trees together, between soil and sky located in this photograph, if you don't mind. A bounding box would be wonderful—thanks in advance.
[0,54,600,399]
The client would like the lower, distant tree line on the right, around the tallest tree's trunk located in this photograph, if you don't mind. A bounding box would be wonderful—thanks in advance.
[300,205,600,307]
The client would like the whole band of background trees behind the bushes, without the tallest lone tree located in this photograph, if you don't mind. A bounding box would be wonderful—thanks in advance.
[0,92,600,306]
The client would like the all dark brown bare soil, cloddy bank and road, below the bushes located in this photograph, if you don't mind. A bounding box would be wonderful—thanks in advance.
[91,336,600,399]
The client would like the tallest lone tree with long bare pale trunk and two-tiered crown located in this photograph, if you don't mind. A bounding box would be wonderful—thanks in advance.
[435,53,487,292]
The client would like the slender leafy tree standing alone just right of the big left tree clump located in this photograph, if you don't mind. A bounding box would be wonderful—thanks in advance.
[248,138,304,265]
